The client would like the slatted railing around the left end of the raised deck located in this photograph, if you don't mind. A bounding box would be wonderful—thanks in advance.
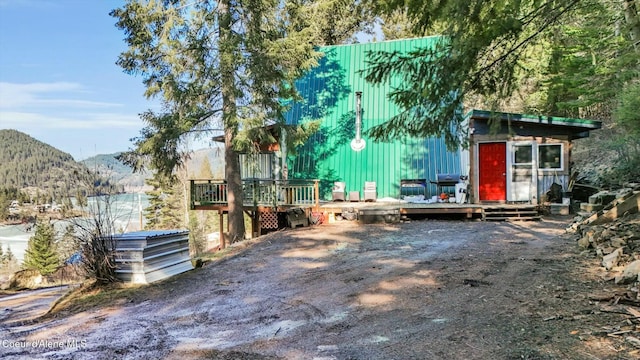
[190,179,319,207]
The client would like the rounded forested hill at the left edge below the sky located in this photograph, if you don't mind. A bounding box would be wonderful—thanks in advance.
[0,130,92,197]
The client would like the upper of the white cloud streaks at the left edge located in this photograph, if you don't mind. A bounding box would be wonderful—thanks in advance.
[0,82,121,109]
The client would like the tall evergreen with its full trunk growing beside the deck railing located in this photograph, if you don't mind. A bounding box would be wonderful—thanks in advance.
[111,0,336,242]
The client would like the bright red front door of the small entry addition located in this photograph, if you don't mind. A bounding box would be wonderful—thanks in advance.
[478,142,507,201]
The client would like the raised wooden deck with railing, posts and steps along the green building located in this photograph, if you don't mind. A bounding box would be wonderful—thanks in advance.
[190,179,540,247]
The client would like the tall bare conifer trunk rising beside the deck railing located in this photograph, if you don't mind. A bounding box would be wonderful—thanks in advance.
[218,0,245,247]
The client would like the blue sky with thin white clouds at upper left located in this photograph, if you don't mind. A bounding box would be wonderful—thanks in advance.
[0,0,159,160]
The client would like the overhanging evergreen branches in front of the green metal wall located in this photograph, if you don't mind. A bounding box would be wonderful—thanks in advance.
[366,0,592,147]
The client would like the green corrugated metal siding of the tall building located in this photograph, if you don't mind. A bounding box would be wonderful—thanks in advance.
[287,37,466,199]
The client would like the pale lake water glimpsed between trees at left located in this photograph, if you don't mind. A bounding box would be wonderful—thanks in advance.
[0,194,149,263]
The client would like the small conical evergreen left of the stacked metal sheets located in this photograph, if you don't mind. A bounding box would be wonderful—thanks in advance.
[23,220,60,275]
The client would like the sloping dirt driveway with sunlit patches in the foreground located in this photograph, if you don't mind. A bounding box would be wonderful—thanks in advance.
[0,218,640,360]
